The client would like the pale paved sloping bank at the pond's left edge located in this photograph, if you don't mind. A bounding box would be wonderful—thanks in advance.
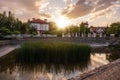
[0,45,19,57]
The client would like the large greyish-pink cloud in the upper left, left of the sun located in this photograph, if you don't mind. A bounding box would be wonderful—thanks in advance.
[0,0,50,21]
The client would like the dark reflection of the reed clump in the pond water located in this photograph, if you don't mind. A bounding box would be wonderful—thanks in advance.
[0,51,90,73]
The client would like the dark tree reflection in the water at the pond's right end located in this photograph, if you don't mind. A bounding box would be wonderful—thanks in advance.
[106,49,120,62]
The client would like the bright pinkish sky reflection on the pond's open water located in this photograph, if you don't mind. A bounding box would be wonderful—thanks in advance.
[0,53,109,80]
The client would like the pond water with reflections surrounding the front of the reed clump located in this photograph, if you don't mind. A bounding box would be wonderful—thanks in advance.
[0,48,120,80]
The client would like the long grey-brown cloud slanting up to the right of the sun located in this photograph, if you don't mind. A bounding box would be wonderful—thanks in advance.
[63,0,119,18]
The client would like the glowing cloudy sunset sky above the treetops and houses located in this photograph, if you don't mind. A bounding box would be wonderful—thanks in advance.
[0,0,120,26]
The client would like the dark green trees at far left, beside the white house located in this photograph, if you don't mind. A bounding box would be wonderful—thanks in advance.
[0,11,37,36]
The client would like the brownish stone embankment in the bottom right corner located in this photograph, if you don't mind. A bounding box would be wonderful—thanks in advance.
[68,59,120,80]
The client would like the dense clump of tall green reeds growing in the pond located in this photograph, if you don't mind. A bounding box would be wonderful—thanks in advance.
[17,42,91,65]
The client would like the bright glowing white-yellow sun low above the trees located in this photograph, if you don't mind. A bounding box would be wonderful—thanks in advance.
[55,16,70,29]
